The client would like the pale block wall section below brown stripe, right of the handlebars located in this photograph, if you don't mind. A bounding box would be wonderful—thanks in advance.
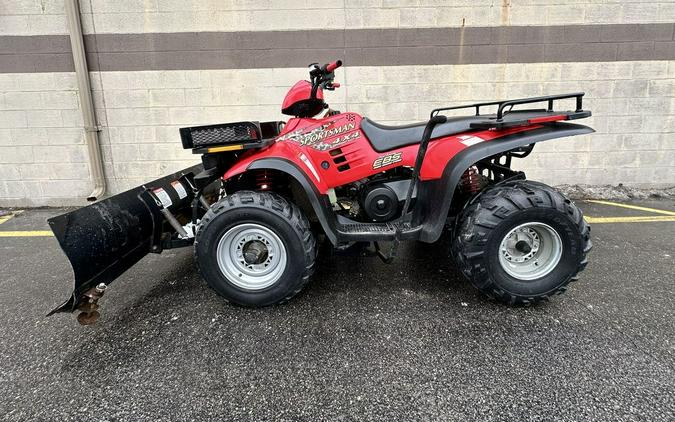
[346,61,675,187]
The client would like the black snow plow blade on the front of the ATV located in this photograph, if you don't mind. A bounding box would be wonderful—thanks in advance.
[48,164,203,316]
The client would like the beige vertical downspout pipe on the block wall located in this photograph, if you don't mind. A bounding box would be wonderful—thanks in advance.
[65,0,106,201]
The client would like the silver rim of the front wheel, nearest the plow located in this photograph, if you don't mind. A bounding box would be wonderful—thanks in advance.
[216,223,286,290]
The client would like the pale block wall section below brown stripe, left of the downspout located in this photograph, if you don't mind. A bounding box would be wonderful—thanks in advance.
[0,73,92,206]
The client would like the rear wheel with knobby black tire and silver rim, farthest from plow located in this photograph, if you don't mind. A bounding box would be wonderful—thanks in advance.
[453,181,592,305]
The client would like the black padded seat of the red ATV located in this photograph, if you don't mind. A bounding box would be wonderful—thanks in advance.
[361,116,485,152]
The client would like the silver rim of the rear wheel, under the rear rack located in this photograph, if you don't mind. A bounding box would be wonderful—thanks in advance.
[499,223,562,280]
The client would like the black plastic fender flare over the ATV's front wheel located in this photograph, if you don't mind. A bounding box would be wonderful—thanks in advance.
[246,158,338,245]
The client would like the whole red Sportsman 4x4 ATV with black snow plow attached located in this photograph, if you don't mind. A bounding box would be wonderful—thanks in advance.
[49,61,593,323]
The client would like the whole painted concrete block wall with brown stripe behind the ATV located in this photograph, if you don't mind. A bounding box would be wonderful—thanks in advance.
[0,0,675,206]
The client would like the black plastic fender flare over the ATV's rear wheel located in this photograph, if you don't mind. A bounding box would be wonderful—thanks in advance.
[415,123,595,243]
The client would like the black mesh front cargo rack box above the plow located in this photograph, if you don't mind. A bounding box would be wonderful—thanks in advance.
[180,122,284,154]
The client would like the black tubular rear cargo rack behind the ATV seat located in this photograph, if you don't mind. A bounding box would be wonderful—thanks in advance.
[431,92,591,129]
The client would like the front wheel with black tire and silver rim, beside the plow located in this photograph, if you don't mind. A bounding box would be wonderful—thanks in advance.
[195,191,316,306]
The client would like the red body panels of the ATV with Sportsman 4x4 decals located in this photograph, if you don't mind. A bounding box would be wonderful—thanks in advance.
[223,109,540,194]
